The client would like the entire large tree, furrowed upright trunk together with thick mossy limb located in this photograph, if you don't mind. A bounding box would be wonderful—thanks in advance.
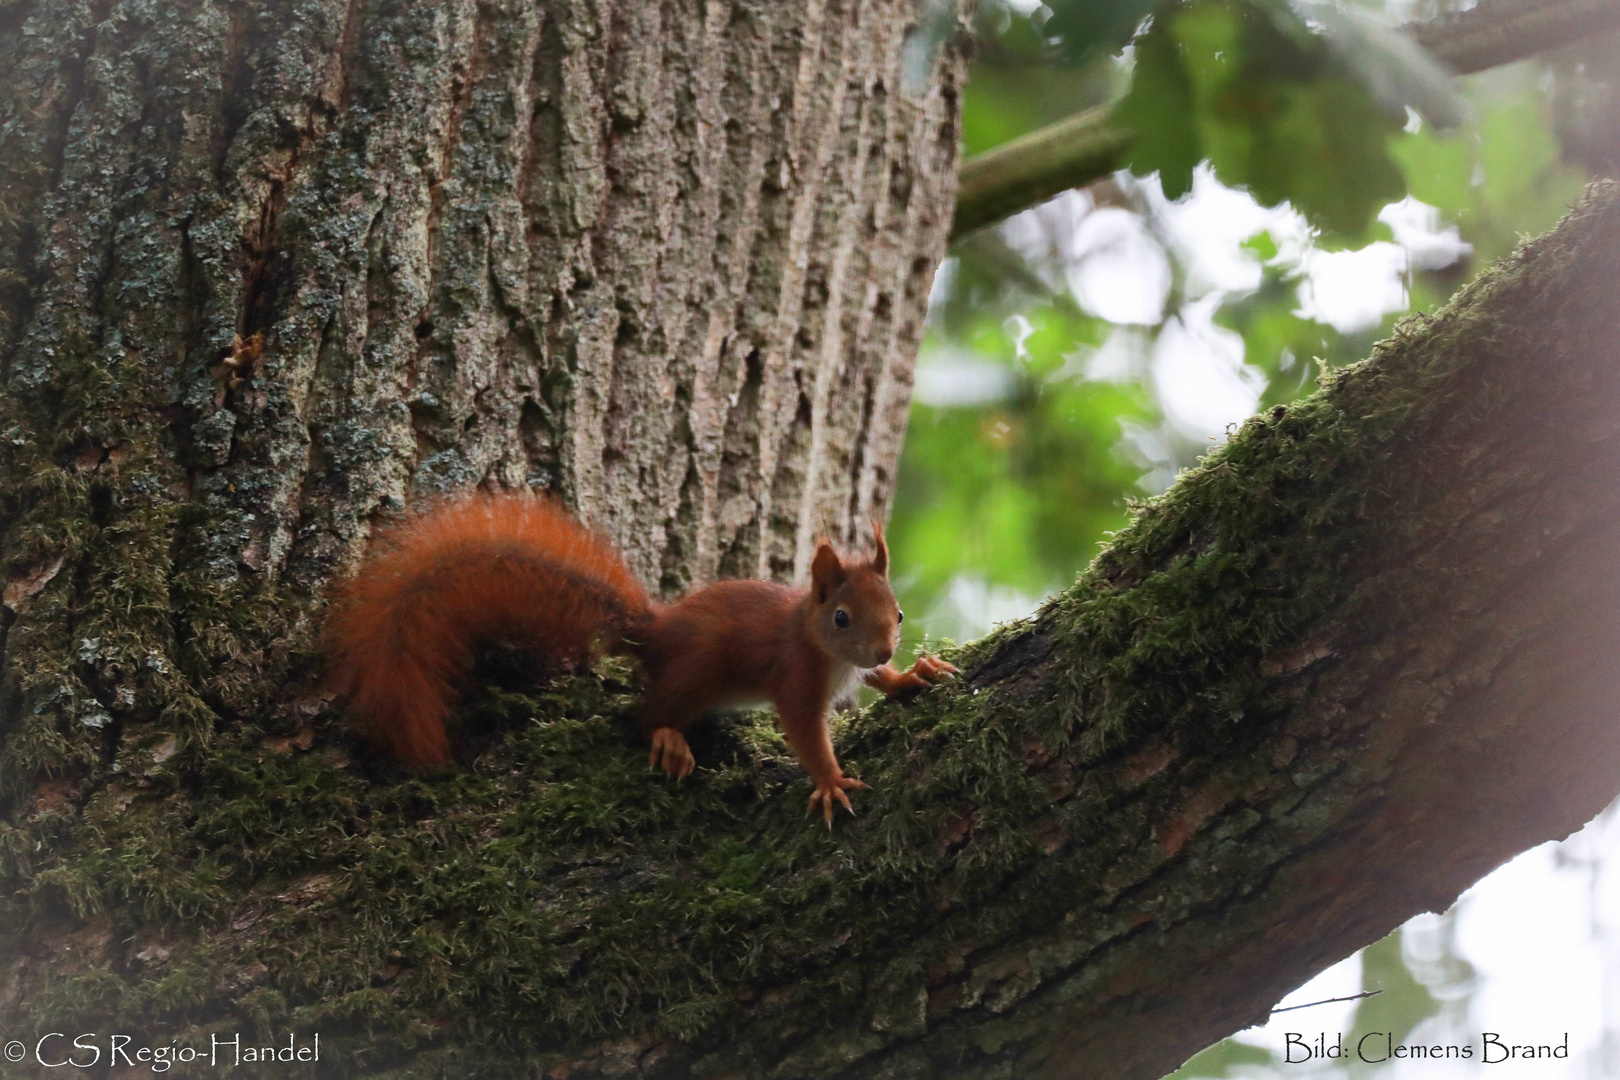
[9,0,1620,1078]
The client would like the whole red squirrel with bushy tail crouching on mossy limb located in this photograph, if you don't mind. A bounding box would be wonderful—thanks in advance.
[326,494,956,826]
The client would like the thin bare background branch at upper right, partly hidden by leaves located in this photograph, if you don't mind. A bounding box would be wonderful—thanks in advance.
[951,0,1620,241]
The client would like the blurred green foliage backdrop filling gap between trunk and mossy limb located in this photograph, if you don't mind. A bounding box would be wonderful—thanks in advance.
[891,0,1600,650]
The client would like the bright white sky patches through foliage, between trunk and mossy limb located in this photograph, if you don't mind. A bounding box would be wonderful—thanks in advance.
[917,167,1468,453]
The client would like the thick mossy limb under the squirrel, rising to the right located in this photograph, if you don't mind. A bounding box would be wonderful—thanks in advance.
[9,152,1620,1078]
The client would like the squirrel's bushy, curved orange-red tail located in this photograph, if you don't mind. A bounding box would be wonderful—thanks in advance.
[326,495,651,769]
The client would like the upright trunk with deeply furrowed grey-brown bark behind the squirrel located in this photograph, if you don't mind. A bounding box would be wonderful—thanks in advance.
[0,0,961,880]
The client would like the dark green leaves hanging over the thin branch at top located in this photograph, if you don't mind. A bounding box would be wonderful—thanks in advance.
[964,0,1461,238]
